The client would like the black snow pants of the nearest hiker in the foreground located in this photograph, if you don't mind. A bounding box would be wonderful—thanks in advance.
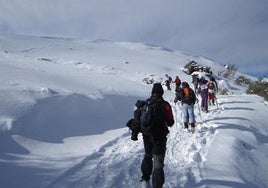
[141,135,167,188]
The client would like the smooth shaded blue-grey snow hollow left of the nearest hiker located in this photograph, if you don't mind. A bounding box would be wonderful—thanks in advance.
[12,94,135,143]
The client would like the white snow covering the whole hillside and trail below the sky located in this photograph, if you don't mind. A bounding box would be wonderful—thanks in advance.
[0,36,268,188]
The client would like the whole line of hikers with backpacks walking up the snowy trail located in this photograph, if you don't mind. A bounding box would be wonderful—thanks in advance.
[127,74,218,188]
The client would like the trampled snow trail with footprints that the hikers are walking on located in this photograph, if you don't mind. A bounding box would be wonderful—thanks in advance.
[47,92,219,188]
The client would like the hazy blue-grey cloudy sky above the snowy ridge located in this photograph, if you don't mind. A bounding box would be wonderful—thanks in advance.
[0,0,268,76]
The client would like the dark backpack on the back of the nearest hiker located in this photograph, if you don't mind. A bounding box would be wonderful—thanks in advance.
[140,99,165,135]
